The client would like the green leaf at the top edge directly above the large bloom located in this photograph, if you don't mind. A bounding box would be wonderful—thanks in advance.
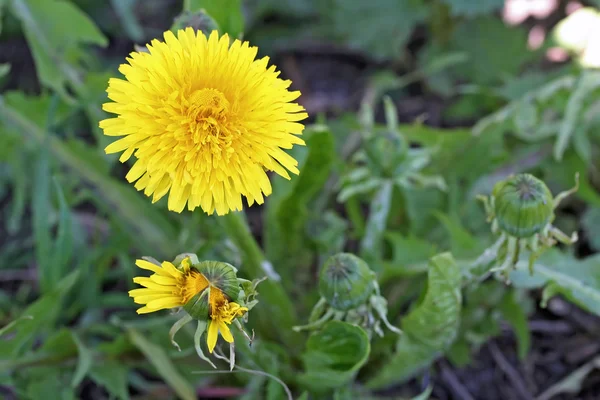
[183,0,244,38]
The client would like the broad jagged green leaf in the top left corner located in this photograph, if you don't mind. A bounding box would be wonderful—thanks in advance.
[10,0,108,97]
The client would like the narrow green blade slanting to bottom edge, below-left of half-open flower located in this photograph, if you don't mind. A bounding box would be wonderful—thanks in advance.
[127,328,196,400]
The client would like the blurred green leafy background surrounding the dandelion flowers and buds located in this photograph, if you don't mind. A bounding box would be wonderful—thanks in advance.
[0,0,600,400]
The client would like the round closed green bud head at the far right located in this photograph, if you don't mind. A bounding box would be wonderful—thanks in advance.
[492,174,554,238]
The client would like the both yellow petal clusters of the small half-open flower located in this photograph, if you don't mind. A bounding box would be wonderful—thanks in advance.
[129,258,248,353]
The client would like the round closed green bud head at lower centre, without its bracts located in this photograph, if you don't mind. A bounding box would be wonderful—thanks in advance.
[319,253,375,311]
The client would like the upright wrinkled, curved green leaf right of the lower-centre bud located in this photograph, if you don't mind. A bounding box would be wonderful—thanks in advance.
[367,253,462,389]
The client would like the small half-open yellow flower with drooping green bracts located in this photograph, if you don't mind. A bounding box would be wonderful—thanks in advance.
[129,253,259,364]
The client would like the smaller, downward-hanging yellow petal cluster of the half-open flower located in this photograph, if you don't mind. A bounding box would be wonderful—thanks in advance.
[206,287,248,353]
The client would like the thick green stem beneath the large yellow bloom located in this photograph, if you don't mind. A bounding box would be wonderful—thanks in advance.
[218,212,301,350]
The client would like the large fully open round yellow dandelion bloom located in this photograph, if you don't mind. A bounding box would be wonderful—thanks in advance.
[100,28,307,215]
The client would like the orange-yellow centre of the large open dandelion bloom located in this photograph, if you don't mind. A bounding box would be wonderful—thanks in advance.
[187,88,233,158]
